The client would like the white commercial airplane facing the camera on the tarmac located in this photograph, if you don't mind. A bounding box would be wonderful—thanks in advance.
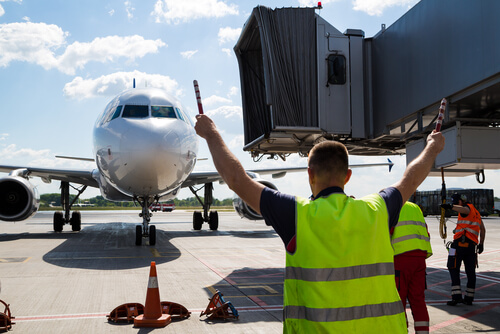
[0,88,393,245]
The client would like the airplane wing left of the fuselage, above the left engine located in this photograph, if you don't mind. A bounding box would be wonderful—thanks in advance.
[0,165,99,188]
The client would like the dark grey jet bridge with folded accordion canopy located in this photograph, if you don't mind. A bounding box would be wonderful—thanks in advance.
[234,0,500,175]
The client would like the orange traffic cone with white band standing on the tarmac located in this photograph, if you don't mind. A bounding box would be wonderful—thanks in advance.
[134,261,172,328]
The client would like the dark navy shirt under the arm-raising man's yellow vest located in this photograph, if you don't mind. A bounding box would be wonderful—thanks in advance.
[260,187,403,253]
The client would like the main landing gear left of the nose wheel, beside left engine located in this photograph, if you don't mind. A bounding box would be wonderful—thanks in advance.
[54,181,87,232]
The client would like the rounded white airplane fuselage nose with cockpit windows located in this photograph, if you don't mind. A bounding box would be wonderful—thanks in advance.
[94,88,198,200]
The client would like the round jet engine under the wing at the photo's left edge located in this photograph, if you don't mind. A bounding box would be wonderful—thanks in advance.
[0,175,40,221]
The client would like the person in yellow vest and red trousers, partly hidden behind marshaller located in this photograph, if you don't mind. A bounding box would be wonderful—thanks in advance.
[391,202,432,334]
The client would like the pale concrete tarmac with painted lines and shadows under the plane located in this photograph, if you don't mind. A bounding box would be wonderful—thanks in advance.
[0,210,500,334]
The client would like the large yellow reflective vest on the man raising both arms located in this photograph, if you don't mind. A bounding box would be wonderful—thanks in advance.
[283,193,407,333]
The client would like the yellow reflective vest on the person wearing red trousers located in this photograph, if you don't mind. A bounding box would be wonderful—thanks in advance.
[391,202,432,257]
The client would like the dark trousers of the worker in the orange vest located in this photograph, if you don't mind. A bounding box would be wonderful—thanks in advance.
[448,238,477,302]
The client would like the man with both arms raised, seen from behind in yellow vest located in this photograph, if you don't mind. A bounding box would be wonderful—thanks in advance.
[195,115,444,333]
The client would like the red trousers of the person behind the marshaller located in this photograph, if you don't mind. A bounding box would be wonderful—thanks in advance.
[394,253,429,333]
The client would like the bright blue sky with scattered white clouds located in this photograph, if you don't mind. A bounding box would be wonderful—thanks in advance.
[0,0,500,199]
